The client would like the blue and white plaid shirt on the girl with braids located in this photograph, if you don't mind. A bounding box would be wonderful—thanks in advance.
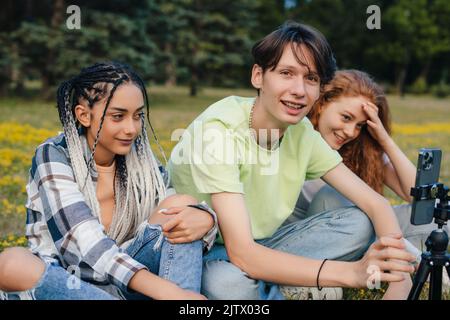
[26,134,217,292]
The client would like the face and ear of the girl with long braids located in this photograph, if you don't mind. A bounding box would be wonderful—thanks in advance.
[75,83,144,165]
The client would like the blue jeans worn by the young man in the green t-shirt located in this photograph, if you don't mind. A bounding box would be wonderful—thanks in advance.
[202,207,375,300]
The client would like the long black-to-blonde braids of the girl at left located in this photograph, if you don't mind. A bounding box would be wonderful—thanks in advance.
[58,62,166,244]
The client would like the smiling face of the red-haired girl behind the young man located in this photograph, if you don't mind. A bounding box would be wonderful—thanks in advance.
[317,96,370,150]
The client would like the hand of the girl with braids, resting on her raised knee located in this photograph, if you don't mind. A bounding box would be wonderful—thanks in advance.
[162,206,214,243]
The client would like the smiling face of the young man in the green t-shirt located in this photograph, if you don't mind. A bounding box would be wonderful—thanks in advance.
[252,44,320,129]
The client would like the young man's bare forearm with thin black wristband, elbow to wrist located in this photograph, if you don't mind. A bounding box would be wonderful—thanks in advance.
[232,243,355,287]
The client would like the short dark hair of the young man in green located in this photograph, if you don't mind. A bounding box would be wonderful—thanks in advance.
[252,21,337,84]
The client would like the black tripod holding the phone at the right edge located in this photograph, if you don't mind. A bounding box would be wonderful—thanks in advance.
[408,183,450,300]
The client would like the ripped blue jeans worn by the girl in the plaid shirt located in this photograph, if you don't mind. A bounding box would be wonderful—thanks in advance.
[0,224,203,300]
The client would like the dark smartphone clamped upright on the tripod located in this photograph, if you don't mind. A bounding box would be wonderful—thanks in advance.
[411,148,442,225]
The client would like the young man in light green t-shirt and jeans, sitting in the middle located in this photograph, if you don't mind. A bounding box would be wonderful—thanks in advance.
[168,22,414,299]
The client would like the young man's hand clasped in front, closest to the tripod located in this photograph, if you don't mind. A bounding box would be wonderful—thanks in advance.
[355,234,416,288]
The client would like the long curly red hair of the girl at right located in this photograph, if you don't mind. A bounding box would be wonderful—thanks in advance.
[308,70,391,194]
